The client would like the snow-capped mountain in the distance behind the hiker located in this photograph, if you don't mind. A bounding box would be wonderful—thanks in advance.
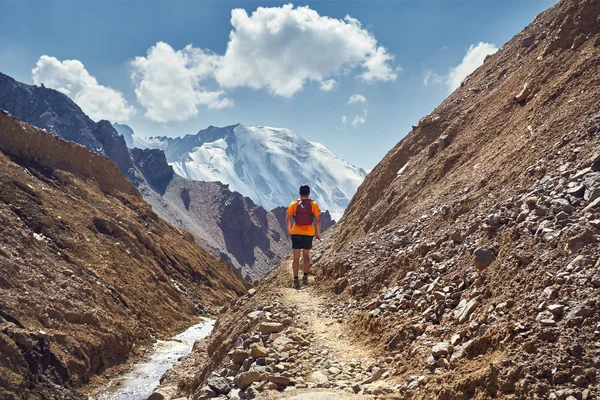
[127,125,366,219]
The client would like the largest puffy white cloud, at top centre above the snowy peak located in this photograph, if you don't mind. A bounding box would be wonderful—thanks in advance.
[216,4,397,97]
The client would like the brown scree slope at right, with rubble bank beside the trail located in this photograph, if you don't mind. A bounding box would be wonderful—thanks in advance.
[168,0,600,400]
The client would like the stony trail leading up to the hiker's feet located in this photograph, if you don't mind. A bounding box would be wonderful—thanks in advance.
[197,264,404,400]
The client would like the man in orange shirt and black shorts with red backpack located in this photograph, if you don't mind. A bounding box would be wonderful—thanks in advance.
[285,185,321,289]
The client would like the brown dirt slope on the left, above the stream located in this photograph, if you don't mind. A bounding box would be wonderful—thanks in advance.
[0,113,246,399]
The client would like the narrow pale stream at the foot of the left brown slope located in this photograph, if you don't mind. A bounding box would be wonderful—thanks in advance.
[97,319,215,400]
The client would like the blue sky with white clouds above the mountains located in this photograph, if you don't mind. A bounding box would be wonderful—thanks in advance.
[0,0,556,170]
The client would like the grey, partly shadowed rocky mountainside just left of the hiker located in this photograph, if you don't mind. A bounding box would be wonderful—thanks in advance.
[136,173,291,281]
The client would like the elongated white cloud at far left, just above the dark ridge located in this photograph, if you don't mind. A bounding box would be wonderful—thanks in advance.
[31,55,135,122]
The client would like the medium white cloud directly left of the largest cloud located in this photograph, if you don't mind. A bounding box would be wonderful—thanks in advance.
[131,42,233,122]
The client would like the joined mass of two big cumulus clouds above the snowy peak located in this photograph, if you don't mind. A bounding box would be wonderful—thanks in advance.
[132,4,394,121]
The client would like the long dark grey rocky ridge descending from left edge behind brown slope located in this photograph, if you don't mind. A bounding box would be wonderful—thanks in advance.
[0,74,288,280]
